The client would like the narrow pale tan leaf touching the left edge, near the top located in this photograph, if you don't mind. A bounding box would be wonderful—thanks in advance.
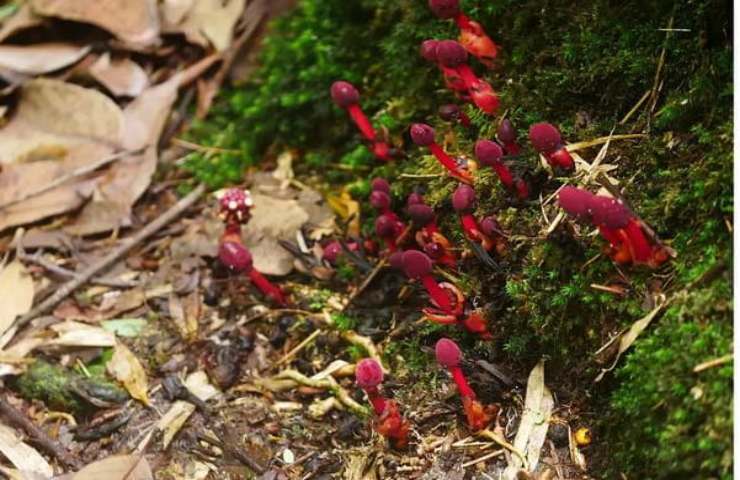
[0,43,90,75]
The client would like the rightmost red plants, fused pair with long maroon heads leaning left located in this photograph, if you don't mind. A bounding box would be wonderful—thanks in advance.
[558,186,669,268]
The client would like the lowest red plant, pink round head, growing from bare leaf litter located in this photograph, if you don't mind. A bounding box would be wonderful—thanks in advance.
[355,358,411,448]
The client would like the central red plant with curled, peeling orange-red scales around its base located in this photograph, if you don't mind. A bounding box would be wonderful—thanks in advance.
[395,250,492,339]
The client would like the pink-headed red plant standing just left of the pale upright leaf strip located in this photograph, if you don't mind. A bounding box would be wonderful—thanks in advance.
[434,338,495,432]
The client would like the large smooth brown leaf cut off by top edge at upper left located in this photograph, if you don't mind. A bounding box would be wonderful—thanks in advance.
[30,0,159,46]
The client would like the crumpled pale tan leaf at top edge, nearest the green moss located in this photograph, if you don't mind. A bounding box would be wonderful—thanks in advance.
[163,0,246,51]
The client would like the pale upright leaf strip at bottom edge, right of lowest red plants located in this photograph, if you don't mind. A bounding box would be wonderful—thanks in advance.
[504,360,554,480]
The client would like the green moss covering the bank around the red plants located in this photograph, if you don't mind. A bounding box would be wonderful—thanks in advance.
[187,0,733,479]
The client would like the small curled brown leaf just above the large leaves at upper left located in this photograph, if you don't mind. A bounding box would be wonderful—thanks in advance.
[89,52,149,97]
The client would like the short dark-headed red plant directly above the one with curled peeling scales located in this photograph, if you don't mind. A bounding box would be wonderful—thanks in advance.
[406,193,457,268]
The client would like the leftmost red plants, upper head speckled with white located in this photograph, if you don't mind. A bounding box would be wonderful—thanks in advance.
[218,188,289,307]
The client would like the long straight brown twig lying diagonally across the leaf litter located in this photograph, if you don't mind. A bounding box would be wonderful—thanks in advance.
[13,184,206,328]
